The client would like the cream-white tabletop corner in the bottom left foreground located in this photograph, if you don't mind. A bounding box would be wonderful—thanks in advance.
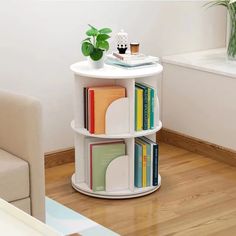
[0,198,62,236]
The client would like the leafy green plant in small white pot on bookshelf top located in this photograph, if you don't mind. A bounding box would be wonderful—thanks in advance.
[81,25,112,69]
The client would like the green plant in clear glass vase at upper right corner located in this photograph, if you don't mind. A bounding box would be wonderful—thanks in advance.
[206,0,236,60]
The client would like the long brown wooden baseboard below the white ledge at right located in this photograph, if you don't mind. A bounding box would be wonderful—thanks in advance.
[157,128,236,166]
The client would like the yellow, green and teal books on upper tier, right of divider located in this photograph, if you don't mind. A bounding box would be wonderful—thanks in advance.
[135,83,155,131]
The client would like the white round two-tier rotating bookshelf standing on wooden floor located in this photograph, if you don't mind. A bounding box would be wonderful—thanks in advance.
[71,61,163,199]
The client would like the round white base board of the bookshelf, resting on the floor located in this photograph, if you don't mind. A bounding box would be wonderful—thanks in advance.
[71,174,161,199]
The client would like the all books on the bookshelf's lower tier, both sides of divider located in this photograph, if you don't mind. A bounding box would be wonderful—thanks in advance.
[84,137,158,192]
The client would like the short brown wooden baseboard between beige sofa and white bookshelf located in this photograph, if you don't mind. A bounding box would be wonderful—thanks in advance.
[44,148,75,169]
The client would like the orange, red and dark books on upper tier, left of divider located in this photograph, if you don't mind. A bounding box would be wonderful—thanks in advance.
[84,86,126,134]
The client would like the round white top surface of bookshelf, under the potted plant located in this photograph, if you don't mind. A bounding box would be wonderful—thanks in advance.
[70,61,163,79]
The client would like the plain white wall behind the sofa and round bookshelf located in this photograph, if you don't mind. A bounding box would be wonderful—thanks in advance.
[0,0,226,152]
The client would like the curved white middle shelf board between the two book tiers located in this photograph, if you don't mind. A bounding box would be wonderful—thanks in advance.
[71,120,162,138]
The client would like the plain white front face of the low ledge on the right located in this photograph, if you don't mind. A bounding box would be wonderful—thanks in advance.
[163,63,236,150]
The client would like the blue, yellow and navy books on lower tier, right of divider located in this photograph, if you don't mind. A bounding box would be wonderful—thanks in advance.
[134,137,158,188]
